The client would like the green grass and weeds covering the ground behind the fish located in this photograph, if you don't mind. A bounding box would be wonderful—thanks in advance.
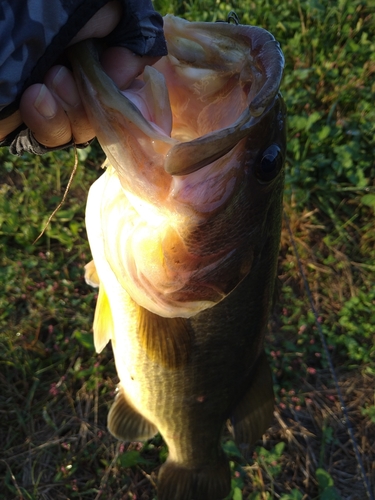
[0,0,375,500]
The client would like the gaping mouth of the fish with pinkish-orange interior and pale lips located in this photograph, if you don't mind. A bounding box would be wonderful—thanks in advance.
[73,15,284,184]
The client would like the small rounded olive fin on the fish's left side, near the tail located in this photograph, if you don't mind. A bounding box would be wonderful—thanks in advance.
[107,386,158,441]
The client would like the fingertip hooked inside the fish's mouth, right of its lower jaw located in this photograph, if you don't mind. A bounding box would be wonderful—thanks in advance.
[101,47,160,90]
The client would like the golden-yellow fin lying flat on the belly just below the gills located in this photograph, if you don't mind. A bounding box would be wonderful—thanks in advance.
[138,306,193,368]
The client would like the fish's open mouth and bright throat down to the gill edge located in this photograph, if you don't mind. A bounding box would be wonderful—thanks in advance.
[72,16,284,317]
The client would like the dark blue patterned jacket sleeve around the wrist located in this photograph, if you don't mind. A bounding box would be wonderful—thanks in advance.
[0,0,167,154]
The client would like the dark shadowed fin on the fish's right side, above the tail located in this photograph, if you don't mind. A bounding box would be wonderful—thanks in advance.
[231,351,275,451]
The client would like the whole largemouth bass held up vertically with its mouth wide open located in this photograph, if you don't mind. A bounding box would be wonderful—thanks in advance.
[70,15,286,500]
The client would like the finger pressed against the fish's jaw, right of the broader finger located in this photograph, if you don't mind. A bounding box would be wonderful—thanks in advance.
[44,66,95,144]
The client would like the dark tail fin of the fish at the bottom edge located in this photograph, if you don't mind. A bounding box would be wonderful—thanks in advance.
[157,453,231,500]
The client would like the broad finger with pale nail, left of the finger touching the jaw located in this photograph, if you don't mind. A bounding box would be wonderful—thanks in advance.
[20,83,72,147]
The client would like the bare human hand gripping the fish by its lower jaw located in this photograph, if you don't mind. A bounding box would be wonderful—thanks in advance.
[0,0,159,152]
